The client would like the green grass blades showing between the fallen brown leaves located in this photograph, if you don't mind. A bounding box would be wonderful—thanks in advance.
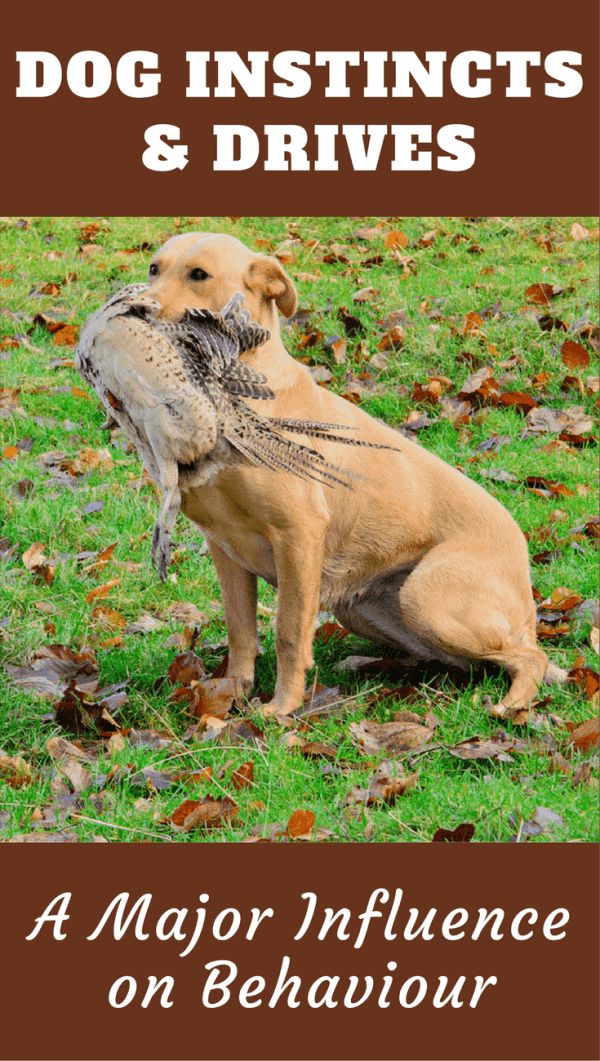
[0,218,598,842]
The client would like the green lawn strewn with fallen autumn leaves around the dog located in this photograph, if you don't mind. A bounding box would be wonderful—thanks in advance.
[0,218,598,842]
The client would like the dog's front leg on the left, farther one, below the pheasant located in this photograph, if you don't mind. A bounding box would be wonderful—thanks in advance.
[207,535,260,692]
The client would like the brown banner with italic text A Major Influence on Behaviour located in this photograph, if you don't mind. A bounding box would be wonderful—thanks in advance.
[1,843,598,1061]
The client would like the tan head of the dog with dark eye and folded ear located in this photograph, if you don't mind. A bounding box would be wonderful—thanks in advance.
[148,232,298,334]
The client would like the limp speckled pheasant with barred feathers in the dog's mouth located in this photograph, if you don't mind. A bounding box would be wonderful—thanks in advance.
[75,283,396,579]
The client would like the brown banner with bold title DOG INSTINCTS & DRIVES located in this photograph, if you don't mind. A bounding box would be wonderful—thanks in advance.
[0,0,598,215]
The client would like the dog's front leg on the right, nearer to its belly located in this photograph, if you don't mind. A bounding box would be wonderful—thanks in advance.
[264,524,324,715]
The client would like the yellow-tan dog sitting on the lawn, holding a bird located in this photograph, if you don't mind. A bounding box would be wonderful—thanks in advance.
[148,232,564,716]
